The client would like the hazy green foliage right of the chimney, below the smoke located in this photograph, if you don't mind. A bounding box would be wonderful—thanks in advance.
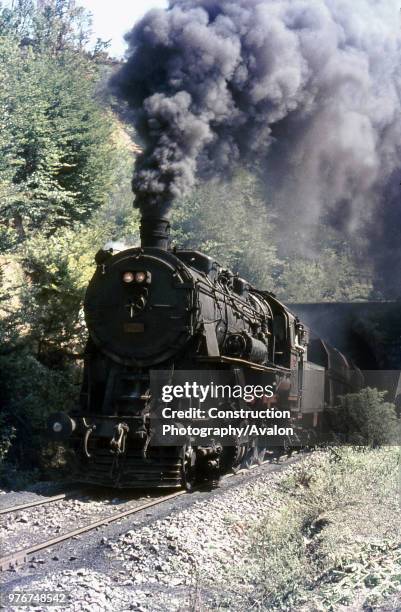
[172,171,372,303]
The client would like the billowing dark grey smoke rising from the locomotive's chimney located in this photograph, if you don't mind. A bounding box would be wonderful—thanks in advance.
[114,0,401,296]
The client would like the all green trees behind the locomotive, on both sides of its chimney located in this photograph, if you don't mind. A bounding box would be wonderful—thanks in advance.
[0,0,376,482]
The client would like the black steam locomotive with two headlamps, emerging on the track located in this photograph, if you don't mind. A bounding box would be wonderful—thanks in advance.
[49,218,359,488]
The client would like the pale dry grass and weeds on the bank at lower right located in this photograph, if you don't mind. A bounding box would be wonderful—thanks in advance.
[248,447,401,612]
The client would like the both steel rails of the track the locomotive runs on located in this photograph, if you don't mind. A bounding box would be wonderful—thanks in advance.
[0,456,298,571]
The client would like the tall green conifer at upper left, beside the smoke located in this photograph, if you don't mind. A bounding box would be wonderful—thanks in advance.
[0,0,118,250]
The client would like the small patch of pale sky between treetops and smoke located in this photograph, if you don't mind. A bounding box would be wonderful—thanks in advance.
[77,0,168,57]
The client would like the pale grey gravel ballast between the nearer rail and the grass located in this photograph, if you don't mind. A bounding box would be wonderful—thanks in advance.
[0,457,310,612]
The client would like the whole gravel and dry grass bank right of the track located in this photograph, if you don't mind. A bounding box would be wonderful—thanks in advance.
[3,449,401,612]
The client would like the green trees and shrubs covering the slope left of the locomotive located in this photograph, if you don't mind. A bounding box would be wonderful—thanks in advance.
[0,0,136,478]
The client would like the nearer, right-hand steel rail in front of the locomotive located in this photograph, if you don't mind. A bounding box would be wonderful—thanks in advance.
[0,490,187,571]
